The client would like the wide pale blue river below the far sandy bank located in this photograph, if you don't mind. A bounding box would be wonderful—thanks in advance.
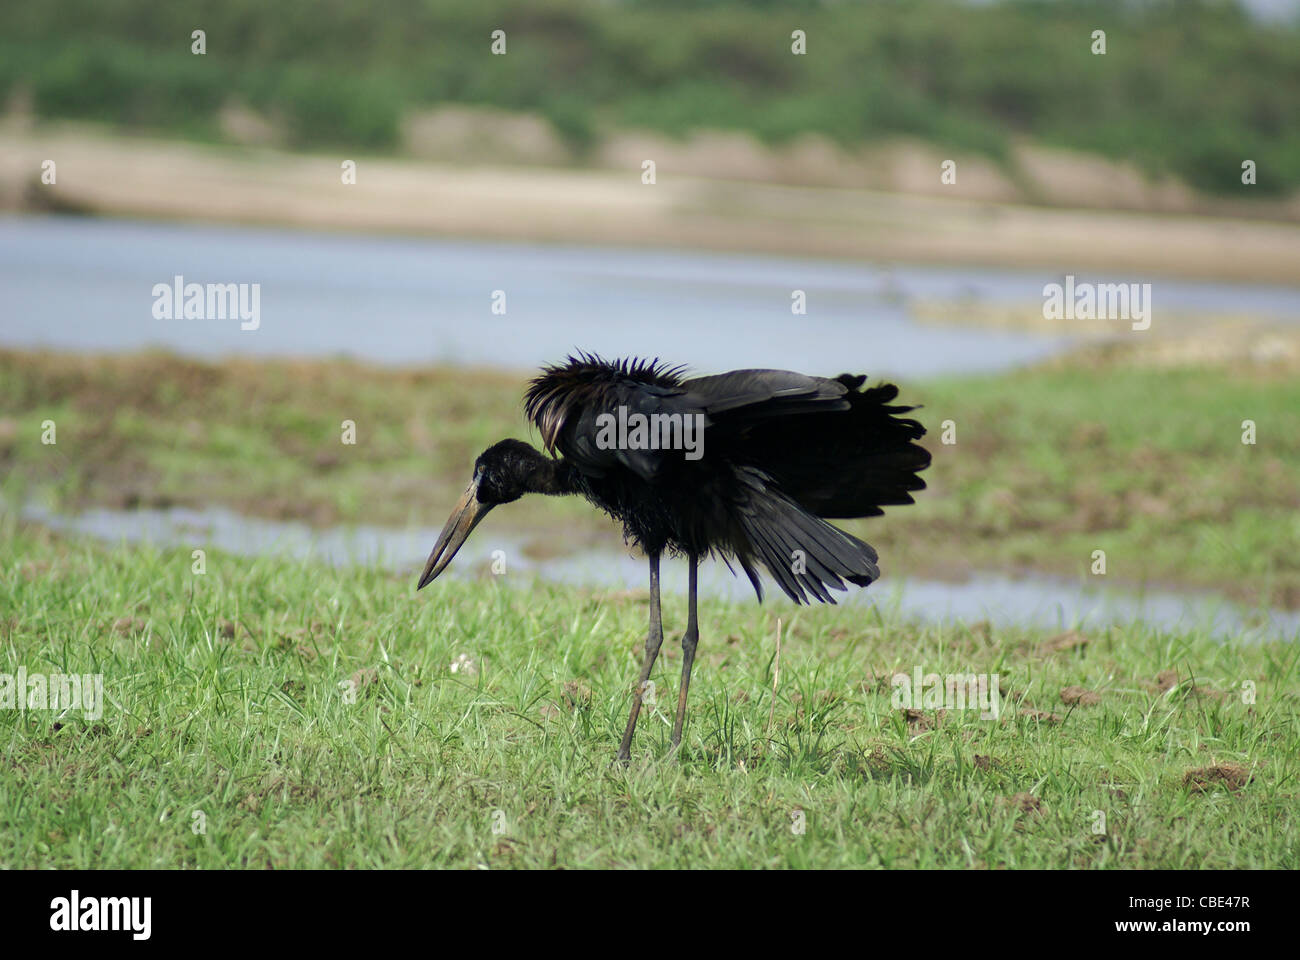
[0,217,1300,376]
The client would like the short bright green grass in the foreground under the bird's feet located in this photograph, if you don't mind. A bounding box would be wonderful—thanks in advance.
[0,514,1300,868]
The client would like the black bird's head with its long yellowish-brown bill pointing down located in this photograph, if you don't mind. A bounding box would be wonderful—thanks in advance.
[416,440,554,589]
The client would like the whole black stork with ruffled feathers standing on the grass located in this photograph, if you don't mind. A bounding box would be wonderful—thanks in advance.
[417,354,930,761]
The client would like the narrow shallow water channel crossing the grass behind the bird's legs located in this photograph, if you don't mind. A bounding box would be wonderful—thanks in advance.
[23,506,1300,641]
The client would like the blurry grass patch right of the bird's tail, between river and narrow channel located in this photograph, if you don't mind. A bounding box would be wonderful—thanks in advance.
[883,363,1300,606]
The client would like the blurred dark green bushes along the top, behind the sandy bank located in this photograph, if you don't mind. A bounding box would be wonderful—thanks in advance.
[0,0,1300,193]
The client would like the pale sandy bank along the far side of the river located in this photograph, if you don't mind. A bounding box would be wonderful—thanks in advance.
[0,124,1300,282]
